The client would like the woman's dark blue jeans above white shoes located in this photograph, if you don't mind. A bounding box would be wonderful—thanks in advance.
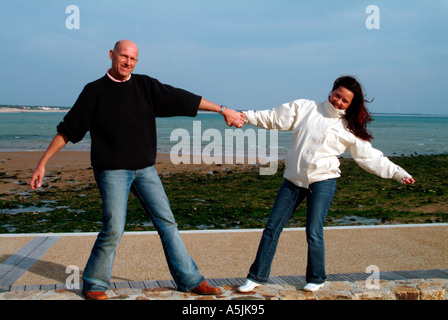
[247,179,336,284]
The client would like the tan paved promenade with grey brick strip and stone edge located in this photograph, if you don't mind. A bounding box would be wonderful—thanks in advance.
[0,224,448,300]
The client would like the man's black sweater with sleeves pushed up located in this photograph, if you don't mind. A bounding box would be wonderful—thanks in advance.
[57,74,201,170]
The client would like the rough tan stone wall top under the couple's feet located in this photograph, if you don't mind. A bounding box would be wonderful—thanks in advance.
[0,279,448,300]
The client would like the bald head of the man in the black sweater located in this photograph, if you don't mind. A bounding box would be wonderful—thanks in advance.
[109,41,138,81]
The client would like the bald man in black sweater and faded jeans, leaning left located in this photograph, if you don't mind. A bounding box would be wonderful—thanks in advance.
[30,40,244,300]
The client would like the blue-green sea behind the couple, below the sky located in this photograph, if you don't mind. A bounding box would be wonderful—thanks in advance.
[0,112,448,159]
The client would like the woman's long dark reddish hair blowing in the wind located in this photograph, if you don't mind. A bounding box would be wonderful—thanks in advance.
[331,76,373,141]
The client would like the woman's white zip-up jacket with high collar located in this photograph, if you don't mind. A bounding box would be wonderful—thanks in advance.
[244,99,411,188]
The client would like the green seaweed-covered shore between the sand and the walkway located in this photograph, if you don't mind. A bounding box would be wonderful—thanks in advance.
[0,154,448,233]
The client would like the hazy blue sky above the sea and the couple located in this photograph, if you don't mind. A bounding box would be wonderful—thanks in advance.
[0,0,448,115]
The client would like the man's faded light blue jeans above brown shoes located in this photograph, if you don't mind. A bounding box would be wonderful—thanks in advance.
[83,166,204,291]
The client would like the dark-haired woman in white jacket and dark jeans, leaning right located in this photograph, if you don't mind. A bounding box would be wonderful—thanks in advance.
[238,76,415,292]
